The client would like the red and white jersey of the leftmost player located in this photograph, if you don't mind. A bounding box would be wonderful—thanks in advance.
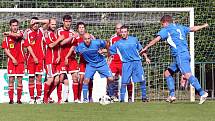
[2,31,25,63]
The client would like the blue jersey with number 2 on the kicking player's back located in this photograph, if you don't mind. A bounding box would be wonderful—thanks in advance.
[157,24,190,56]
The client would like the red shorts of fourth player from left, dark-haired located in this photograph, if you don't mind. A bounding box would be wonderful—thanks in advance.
[60,59,78,73]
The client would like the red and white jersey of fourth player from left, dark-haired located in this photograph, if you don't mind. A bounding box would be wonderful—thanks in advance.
[57,27,78,61]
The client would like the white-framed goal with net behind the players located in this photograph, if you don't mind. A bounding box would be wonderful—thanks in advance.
[0,8,195,101]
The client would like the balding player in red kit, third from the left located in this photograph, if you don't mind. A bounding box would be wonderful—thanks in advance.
[43,18,64,104]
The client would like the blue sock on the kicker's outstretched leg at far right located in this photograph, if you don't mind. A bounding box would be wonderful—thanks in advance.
[188,75,205,96]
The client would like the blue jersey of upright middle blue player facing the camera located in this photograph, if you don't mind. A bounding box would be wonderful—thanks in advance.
[110,36,142,62]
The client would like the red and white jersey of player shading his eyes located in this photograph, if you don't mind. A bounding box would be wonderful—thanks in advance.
[24,28,44,62]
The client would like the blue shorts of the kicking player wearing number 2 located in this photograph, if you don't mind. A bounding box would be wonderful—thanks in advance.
[168,53,191,74]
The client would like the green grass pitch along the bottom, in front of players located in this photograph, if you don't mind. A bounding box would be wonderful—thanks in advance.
[0,101,215,121]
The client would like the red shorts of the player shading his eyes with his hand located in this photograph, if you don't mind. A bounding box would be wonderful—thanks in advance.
[27,62,44,76]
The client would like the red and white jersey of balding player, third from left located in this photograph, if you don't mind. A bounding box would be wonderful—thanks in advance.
[45,31,59,64]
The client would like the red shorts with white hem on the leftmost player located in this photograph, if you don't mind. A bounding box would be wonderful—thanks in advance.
[7,60,25,76]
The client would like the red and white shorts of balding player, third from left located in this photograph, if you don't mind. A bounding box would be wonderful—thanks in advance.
[45,64,60,77]
